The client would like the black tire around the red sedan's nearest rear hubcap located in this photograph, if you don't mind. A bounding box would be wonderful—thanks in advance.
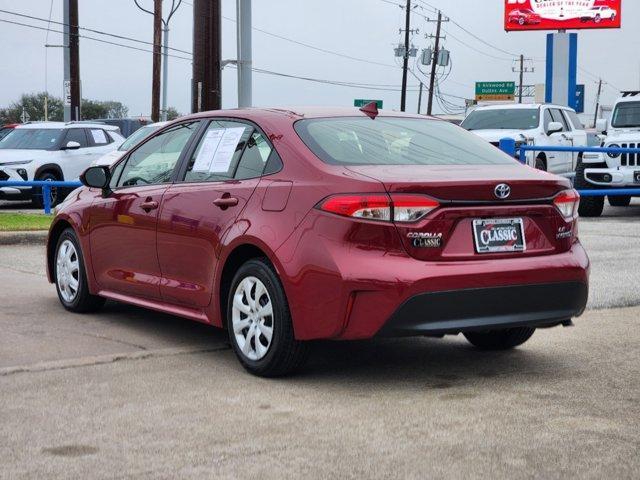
[227,258,309,377]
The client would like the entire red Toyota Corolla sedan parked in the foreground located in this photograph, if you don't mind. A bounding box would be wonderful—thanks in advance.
[47,106,589,376]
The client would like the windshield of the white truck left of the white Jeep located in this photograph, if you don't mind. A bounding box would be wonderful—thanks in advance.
[461,108,540,130]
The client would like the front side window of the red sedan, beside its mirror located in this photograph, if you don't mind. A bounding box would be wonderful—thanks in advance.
[116,122,198,187]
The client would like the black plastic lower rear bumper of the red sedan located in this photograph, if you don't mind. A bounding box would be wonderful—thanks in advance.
[378,282,589,336]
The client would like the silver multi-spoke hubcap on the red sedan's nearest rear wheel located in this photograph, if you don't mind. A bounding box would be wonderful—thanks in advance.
[231,277,273,361]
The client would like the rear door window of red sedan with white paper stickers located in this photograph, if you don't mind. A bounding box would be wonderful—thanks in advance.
[184,120,252,182]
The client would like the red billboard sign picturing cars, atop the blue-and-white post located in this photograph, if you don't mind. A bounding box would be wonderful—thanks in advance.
[504,0,622,32]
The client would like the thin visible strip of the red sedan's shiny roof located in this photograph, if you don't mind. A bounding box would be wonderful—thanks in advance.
[180,106,433,121]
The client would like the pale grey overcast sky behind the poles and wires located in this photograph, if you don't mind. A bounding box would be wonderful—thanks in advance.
[0,0,640,115]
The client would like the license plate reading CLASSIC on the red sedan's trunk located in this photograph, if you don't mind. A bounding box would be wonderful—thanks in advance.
[473,218,526,253]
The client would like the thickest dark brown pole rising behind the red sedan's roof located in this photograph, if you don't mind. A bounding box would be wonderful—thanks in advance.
[191,0,222,113]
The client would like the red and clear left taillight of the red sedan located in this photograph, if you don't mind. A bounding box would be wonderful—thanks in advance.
[318,194,439,223]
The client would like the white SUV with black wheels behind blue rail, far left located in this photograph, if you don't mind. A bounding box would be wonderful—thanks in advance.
[0,122,124,206]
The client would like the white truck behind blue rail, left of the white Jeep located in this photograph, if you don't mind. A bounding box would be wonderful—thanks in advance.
[461,103,587,175]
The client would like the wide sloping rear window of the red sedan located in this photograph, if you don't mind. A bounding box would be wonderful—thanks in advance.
[295,117,514,165]
